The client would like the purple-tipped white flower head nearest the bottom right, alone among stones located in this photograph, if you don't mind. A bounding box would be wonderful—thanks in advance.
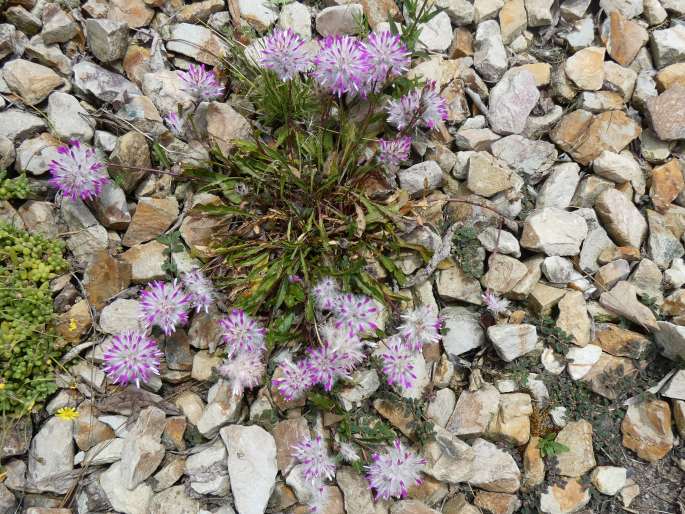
[366,439,426,500]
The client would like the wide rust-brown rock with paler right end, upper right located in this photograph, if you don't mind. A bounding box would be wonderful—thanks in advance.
[550,109,642,165]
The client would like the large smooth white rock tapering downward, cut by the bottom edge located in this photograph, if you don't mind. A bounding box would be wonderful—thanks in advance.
[221,425,278,514]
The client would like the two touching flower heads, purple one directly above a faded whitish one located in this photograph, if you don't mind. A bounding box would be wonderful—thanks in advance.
[219,309,266,395]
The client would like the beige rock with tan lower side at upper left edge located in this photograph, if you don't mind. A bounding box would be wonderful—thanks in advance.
[2,59,62,105]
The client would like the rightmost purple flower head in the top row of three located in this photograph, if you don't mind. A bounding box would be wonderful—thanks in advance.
[362,30,411,83]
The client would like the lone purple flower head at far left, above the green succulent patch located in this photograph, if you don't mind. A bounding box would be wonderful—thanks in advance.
[48,140,109,201]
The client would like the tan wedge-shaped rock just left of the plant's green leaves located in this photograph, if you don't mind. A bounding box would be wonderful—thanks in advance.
[122,196,178,247]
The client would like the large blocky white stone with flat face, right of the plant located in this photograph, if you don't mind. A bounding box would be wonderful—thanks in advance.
[520,207,588,256]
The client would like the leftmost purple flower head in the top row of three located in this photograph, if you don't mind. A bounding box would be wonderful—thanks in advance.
[259,29,312,82]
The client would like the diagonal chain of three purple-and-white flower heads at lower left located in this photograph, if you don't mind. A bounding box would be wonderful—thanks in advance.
[103,270,214,387]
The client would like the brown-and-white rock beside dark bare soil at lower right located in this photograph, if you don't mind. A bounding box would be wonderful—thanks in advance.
[621,400,673,462]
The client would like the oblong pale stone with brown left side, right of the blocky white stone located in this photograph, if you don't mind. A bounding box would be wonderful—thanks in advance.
[595,189,647,248]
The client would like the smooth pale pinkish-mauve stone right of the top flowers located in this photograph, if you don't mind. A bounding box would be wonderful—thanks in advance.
[488,69,540,135]
